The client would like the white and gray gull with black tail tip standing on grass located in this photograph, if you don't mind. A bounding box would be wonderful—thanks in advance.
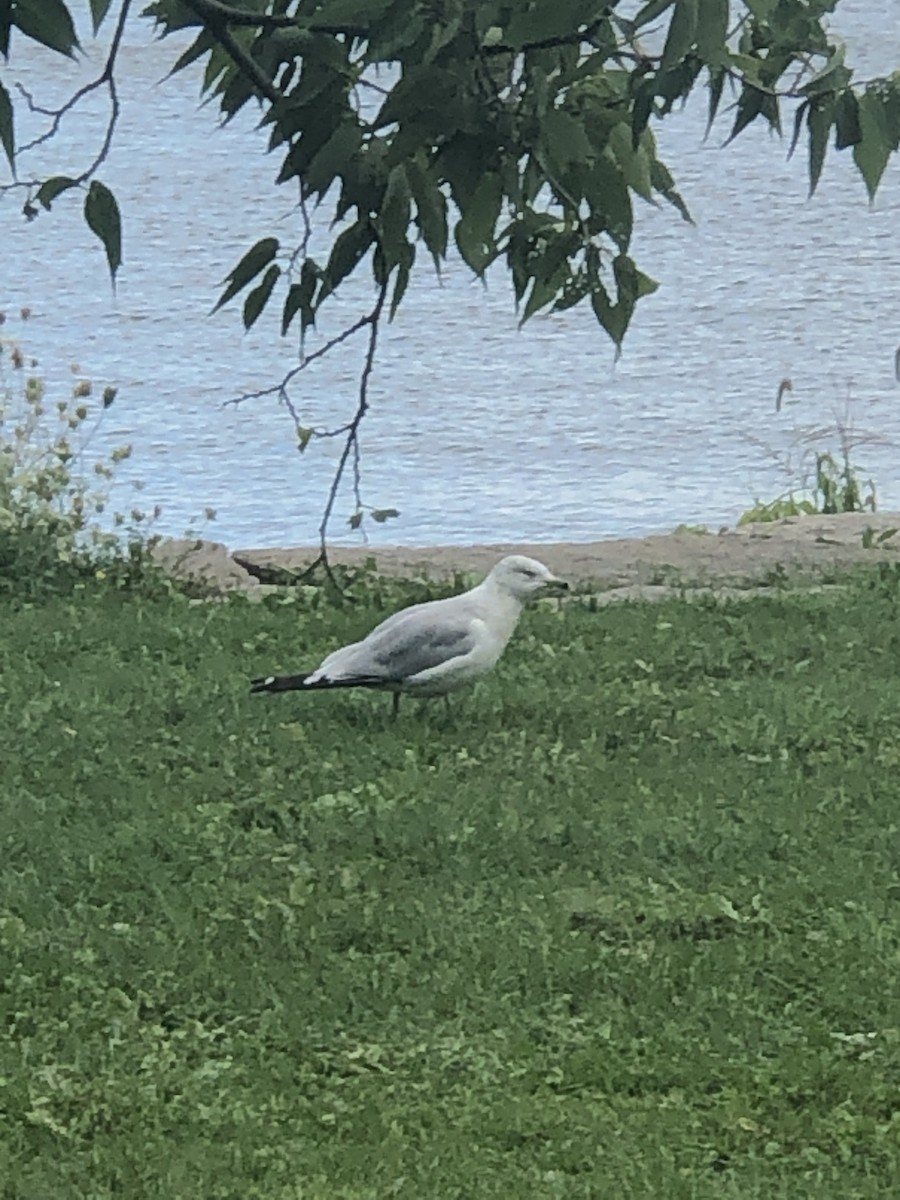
[250,554,569,716]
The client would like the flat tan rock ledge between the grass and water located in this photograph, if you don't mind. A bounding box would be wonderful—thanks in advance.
[154,512,900,593]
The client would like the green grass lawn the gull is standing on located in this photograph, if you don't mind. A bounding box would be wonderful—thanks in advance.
[0,572,900,1200]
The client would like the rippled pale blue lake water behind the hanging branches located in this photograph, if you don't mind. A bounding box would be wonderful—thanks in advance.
[0,0,900,546]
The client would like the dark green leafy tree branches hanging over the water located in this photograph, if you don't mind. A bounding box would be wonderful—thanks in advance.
[0,0,900,549]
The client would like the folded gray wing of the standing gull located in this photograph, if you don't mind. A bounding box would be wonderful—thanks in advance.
[341,596,478,682]
